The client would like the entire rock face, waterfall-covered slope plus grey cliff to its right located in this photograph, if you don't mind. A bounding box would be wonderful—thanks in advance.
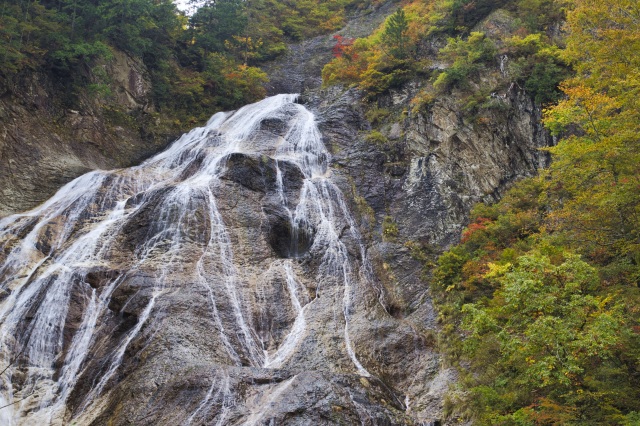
[0,78,548,425]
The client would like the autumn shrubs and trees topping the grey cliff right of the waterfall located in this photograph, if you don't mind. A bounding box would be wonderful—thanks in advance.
[323,0,569,111]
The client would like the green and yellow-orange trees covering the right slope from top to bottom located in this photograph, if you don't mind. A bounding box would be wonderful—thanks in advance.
[418,0,640,425]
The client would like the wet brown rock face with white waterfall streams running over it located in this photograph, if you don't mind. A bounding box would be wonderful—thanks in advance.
[0,95,416,424]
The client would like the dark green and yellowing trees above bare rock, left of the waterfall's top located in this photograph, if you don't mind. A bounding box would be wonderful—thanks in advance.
[0,0,368,121]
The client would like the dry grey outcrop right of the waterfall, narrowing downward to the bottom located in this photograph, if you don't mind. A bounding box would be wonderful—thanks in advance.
[306,80,552,421]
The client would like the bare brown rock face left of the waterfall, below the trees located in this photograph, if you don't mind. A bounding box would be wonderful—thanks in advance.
[0,51,175,217]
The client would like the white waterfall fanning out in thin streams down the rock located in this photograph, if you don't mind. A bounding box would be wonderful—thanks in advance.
[0,95,380,425]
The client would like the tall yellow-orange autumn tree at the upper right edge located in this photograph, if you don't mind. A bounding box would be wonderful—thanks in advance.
[545,0,640,269]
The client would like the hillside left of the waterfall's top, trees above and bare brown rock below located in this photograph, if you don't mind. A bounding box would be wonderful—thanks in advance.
[0,0,375,216]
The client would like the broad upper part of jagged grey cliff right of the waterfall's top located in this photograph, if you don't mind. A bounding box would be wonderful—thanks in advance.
[316,87,553,248]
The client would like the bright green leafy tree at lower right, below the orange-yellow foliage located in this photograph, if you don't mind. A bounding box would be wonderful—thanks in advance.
[462,251,638,424]
